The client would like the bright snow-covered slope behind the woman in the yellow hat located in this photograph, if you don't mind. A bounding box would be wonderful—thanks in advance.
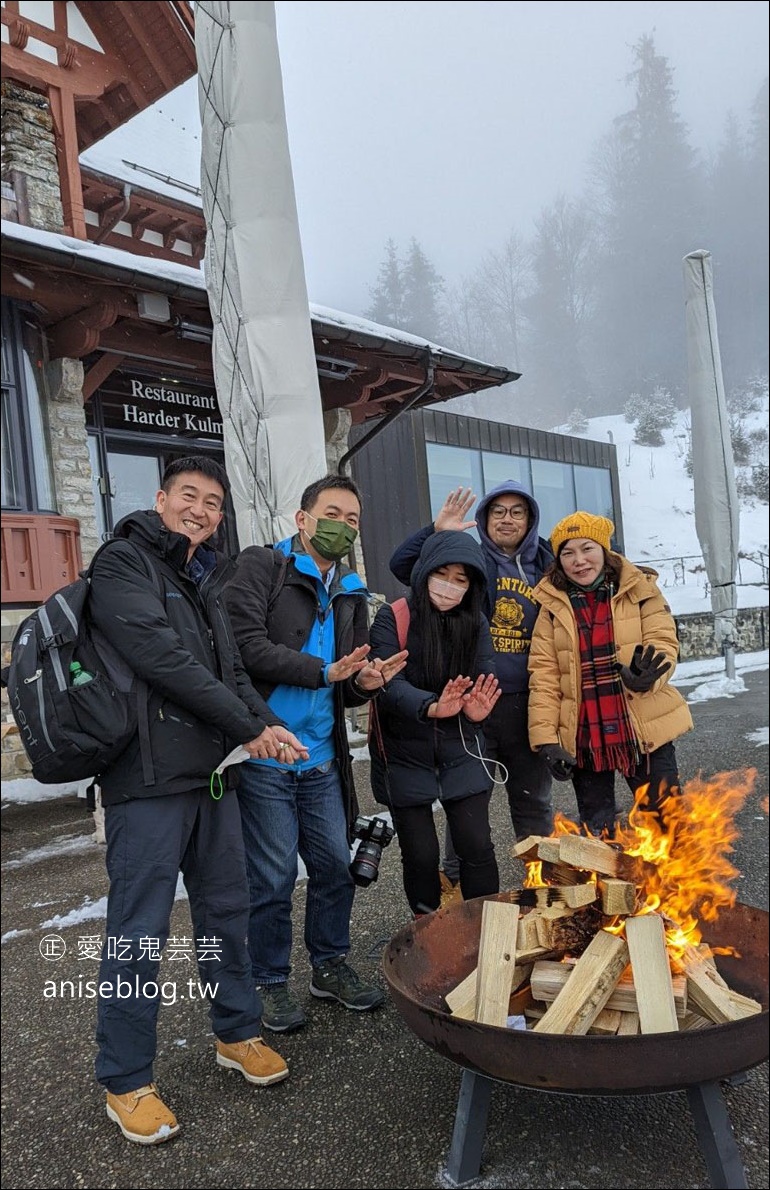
[557,393,769,615]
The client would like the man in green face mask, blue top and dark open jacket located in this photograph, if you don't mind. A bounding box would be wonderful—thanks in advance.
[225,475,406,1033]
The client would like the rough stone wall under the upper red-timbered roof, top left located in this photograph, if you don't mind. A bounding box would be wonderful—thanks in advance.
[0,79,64,231]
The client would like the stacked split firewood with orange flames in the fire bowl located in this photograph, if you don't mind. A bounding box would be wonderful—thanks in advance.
[446,771,763,1036]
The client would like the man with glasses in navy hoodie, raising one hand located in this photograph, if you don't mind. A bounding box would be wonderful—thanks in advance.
[390,480,553,847]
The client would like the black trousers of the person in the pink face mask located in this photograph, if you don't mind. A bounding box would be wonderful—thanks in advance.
[392,794,500,913]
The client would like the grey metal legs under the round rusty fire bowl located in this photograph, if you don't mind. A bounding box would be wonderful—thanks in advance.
[446,1070,749,1190]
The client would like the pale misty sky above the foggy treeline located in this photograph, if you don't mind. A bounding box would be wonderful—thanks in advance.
[176,0,768,313]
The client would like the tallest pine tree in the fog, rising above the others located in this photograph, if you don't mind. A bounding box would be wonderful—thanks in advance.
[591,35,703,412]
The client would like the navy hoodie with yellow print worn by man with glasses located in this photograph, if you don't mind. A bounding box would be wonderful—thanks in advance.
[390,480,553,694]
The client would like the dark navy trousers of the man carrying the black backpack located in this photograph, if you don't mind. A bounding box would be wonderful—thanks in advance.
[96,789,262,1095]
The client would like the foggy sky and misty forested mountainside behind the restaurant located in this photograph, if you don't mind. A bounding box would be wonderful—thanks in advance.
[163,0,768,426]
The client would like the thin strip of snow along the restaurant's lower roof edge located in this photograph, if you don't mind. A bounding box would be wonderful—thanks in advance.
[2,221,490,368]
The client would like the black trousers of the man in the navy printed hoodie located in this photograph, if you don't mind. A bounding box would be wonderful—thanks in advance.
[444,690,553,882]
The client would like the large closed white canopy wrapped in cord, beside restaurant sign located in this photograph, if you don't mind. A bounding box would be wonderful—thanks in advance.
[195,0,326,549]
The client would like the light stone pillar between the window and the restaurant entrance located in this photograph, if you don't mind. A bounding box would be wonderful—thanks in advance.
[45,359,99,565]
